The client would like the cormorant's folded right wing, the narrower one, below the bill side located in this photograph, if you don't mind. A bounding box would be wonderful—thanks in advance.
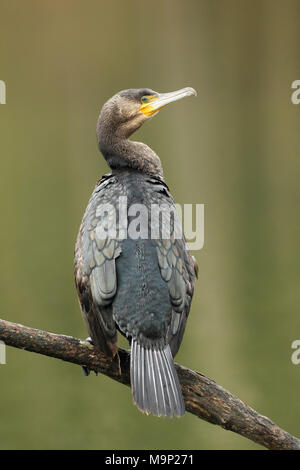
[146,178,197,356]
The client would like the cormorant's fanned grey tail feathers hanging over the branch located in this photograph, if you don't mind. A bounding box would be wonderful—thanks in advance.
[130,339,184,417]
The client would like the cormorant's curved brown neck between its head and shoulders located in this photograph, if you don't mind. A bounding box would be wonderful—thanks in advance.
[99,134,163,180]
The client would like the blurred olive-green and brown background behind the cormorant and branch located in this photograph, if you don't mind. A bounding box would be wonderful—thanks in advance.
[0,0,300,449]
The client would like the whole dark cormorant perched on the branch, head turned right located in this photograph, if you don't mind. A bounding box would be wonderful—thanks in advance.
[74,87,198,417]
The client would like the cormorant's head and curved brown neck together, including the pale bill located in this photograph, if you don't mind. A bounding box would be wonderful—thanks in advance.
[97,88,196,177]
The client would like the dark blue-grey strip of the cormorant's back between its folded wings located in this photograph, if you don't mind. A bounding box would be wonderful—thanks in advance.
[113,172,173,344]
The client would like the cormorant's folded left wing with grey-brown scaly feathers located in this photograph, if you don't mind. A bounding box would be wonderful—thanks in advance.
[75,175,122,356]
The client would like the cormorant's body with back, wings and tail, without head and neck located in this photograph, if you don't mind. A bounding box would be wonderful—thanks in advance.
[75,170,194,416]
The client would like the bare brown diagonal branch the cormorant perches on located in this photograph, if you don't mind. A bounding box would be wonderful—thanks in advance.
[0,319,300,450]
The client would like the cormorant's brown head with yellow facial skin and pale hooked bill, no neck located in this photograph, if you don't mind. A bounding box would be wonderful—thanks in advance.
[97,88,197,140]
